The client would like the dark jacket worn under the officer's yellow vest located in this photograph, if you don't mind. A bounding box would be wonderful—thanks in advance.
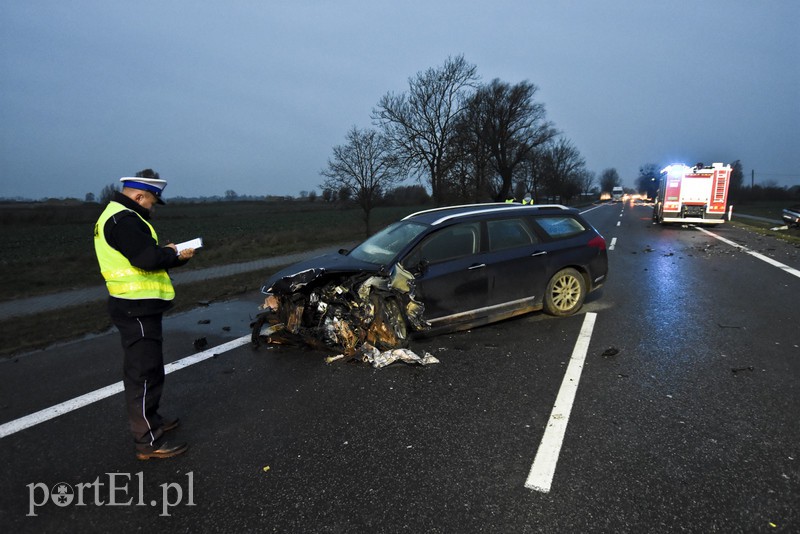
[103,191,188,317]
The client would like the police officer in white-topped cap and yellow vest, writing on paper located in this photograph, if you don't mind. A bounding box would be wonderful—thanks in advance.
[94,169,194,460]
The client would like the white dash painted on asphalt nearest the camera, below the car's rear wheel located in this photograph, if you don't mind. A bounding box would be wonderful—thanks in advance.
[525,312,597,493]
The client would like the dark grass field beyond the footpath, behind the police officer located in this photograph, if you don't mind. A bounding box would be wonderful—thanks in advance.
[0,201,424,301]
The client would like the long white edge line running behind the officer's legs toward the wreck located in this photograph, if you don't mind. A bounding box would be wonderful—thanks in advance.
[0,335,251,439]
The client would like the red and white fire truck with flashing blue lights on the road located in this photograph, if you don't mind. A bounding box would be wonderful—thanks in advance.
[653,163,733,224]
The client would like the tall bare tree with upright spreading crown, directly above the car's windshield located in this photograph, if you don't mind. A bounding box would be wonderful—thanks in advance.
[372,56,478,205]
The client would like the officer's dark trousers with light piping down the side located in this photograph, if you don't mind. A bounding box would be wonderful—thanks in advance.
[111,310,164,447]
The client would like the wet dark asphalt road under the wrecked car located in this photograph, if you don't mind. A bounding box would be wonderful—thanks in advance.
[0,204,800,533]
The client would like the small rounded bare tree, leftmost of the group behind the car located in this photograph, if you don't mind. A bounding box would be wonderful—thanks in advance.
[320,126,403,236]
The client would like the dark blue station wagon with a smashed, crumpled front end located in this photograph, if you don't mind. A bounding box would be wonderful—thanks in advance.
[253,203,608,355]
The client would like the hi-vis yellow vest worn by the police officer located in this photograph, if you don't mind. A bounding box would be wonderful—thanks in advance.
[94,201,175,300]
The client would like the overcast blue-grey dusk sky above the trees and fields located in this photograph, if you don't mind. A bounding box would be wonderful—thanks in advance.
[0,0,800,200]
